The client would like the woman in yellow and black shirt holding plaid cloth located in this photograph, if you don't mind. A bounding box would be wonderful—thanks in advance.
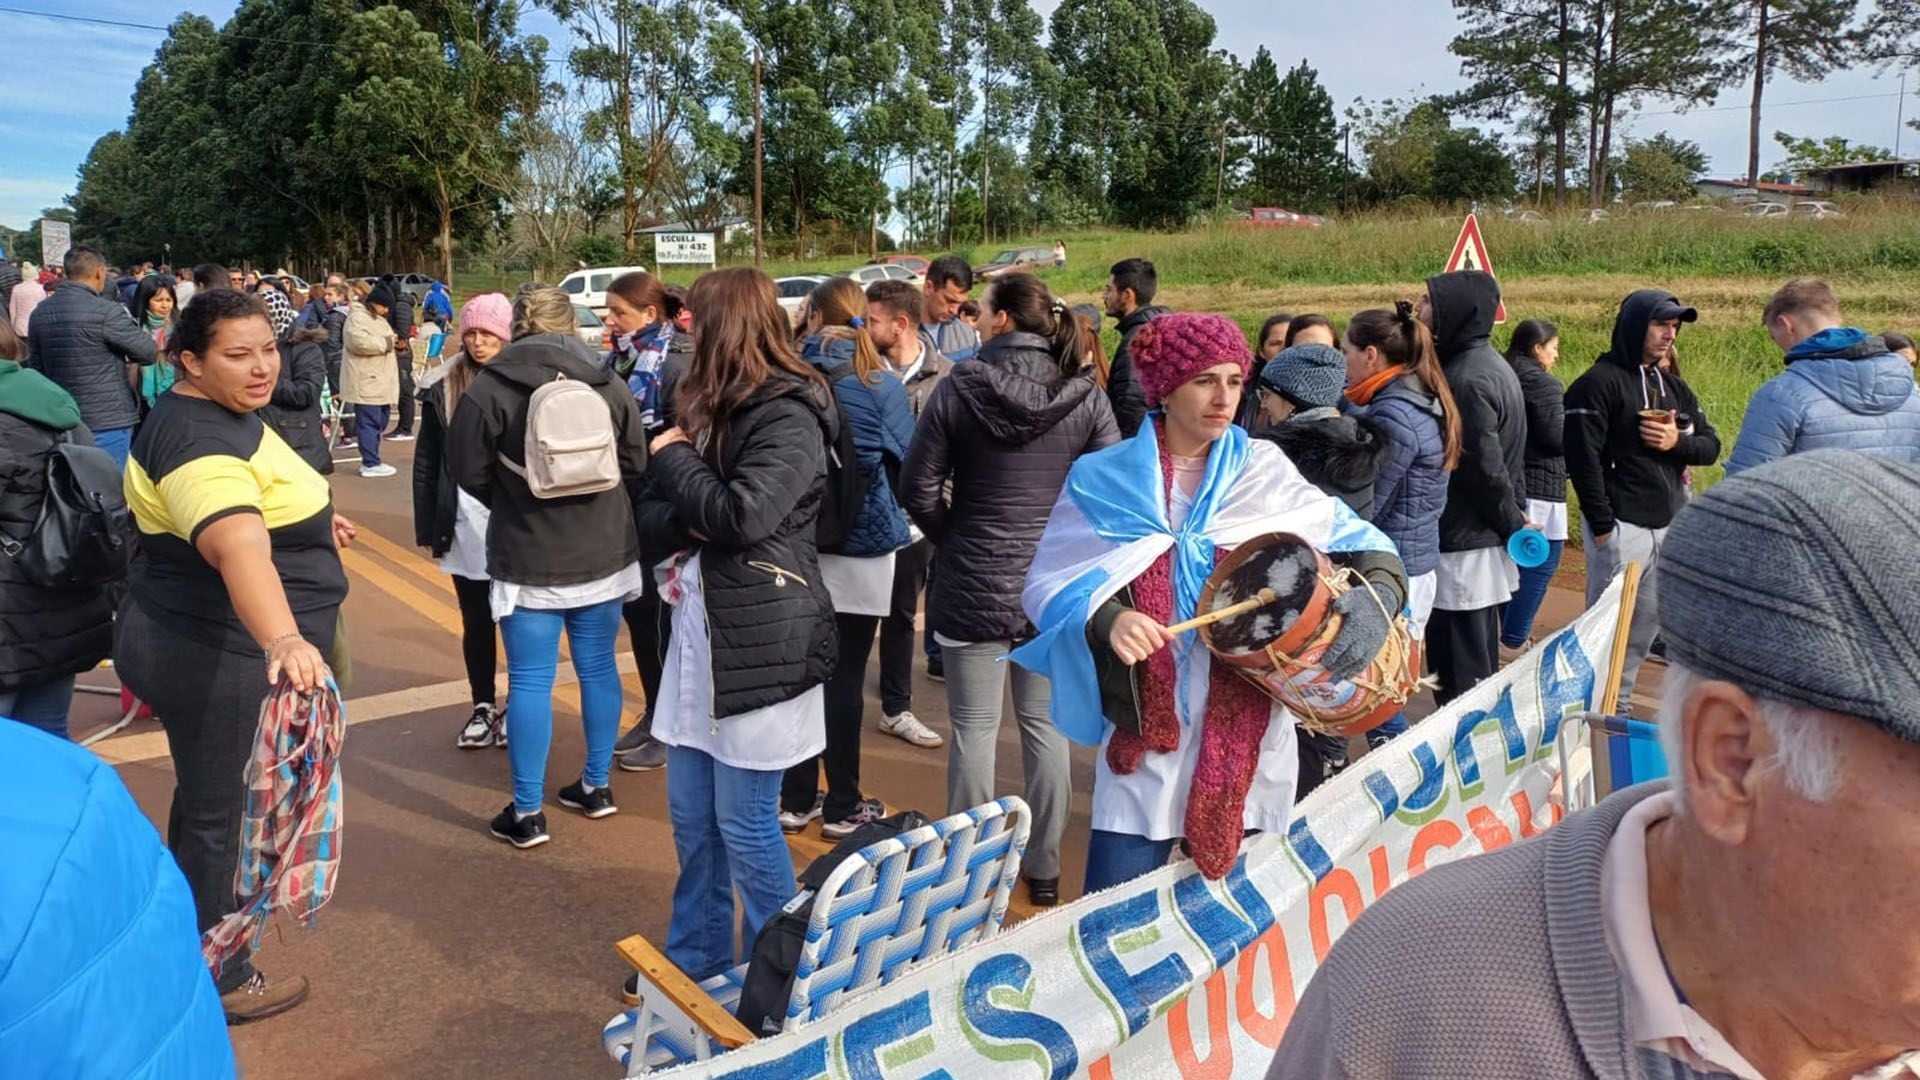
[115,288,353,1020]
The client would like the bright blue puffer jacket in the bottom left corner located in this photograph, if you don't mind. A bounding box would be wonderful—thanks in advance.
[0,721,234,1080]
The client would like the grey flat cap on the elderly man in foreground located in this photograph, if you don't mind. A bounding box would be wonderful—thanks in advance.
[1657,450,1920,742]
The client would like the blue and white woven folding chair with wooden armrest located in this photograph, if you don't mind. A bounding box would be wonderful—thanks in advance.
[601,796,1033,1076]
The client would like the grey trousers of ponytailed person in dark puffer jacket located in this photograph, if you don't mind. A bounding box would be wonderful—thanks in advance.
[941,642,1073,880]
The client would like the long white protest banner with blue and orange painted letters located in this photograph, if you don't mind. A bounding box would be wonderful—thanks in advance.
[662,580,1630,1080]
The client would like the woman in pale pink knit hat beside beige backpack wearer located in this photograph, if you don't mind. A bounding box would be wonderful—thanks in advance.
[413,292,513,749]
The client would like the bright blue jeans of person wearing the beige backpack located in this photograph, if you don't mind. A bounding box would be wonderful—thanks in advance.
[495,591,622,813]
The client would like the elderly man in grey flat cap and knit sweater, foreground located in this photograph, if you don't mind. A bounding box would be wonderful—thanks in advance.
[1269,450,1920,1080]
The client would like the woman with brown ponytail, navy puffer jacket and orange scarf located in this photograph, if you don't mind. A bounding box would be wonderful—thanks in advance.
[1340,300,1461,746]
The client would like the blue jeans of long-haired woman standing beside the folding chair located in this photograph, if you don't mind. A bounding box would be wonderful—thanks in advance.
[660,745,797,982]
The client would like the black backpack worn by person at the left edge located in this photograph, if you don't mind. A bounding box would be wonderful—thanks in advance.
[4,432,134,588]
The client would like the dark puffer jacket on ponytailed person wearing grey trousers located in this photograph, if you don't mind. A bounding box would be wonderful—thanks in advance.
[900,332,1119,642]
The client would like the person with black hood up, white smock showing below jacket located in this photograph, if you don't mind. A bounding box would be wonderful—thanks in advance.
[1419,271,1526,705]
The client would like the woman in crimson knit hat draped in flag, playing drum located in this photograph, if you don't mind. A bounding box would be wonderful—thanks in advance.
[1014,313,1407,894]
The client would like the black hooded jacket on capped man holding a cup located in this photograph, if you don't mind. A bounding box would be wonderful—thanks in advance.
[1567,288,1720,536]
